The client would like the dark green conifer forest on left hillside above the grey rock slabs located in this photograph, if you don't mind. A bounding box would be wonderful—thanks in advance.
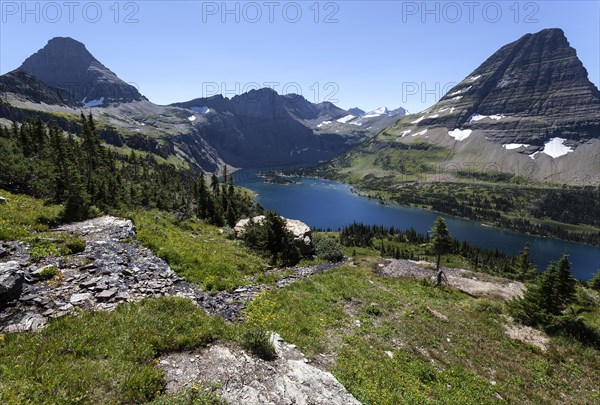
[0,114,255,226]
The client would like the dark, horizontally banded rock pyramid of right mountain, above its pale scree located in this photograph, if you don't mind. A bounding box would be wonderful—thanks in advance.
[410,29,600,147]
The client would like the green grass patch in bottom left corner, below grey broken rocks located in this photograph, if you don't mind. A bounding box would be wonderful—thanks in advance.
[0,298,227,404]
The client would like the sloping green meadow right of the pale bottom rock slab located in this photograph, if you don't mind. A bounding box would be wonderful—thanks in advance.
[248,267,600,404]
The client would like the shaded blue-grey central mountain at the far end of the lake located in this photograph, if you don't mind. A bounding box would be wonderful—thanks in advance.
[173,88,368,167]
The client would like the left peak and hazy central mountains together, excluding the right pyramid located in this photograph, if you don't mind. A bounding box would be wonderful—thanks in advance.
[0,38,404,171]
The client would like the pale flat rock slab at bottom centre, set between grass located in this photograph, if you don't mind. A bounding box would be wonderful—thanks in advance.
[158,333,360,405]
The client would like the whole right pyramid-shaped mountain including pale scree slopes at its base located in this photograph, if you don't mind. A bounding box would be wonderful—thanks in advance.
[328,29,600,184]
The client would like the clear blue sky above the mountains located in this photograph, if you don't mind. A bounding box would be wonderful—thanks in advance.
[0,0,600,112]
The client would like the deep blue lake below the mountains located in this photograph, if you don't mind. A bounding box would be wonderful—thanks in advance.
[234,170,600,280]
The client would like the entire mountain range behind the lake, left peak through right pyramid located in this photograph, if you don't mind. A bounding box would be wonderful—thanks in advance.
[0,29,600,184]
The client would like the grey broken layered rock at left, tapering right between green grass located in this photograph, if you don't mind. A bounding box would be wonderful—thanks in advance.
[0,216,344,333]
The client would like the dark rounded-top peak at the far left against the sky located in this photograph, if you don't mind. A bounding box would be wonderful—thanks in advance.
[20,37,146,107]
